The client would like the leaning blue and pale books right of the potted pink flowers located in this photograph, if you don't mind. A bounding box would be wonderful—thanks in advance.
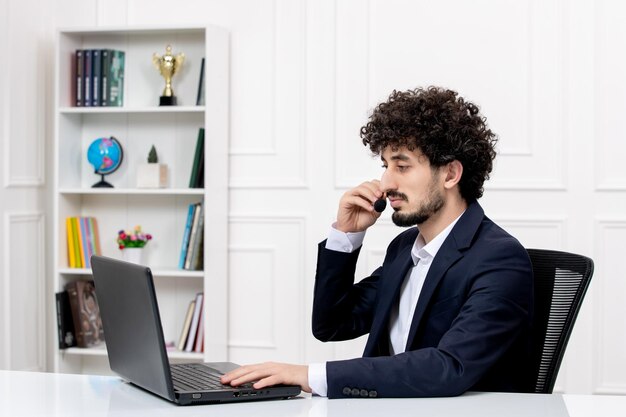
[178,203,204,271]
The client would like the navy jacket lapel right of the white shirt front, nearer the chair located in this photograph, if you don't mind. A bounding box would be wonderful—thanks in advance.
[405,201,485,350]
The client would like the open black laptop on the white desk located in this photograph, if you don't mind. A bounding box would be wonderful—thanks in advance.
[91,255,301,405]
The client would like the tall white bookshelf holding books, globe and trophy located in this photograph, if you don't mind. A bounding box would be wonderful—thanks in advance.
[49,26,229,373]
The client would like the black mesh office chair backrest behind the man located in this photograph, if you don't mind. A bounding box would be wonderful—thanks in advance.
[527,249,593,394]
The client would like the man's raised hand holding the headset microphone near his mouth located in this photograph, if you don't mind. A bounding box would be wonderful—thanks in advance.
[335,180,383,233]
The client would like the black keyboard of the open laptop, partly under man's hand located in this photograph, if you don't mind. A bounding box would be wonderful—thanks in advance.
[170,363,252,391]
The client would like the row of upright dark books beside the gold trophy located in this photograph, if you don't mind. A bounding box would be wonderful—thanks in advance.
[74,49,126,107]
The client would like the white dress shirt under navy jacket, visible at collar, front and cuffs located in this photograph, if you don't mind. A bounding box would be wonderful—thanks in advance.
[308,214,463,397]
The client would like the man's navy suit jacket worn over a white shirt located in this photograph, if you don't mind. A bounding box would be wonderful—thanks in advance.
[313,201,533,398]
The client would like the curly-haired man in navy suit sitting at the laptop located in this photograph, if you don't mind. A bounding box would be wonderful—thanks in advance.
[223,87,533,398]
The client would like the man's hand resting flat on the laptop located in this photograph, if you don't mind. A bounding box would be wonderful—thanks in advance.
[222,362,311,392]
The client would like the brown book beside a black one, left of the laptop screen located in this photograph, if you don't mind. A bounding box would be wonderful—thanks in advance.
[65,281,104,347]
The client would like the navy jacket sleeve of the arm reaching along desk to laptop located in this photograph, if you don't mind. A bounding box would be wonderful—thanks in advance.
[326,237,532,398]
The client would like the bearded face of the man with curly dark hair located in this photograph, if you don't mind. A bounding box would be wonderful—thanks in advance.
[381,147,445,227]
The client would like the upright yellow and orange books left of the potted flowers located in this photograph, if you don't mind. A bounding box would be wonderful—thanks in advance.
[65,217,102,268]
